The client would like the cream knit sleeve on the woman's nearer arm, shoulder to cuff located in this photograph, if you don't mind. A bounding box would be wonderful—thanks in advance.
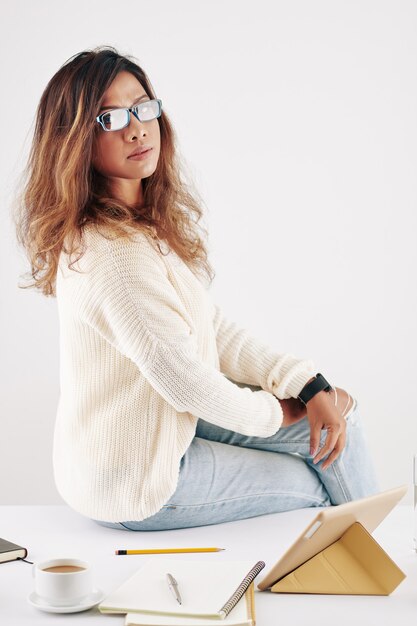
[82,236,283,437]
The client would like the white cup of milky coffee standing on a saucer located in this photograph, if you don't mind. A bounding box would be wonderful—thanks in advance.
[32,558,93,606]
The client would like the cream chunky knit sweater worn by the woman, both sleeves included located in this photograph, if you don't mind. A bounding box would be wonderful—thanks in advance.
[53,227,315,522]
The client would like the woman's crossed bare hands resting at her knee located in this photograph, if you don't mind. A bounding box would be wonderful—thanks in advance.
[278,387,353,470]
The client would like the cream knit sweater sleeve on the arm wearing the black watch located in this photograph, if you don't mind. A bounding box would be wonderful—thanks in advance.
[213,303,316,400]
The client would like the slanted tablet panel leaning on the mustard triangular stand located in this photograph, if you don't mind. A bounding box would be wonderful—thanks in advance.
[258,485,408,591]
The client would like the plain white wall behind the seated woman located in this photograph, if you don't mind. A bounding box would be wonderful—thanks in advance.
[0,0,417,504]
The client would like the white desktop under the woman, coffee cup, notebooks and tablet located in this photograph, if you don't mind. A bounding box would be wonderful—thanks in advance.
[0,505,417,626]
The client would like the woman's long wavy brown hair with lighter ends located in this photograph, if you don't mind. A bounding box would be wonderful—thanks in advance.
[14,46,215,296]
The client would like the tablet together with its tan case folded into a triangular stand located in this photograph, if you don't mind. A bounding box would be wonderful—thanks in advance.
[258,485,407,595]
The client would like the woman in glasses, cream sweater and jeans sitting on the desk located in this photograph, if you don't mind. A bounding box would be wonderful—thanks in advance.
[17,47,378,530]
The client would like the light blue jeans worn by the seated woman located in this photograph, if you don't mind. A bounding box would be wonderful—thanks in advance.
[94,387,379,531]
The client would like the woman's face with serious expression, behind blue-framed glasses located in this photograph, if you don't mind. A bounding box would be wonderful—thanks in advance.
[92,71,161,188]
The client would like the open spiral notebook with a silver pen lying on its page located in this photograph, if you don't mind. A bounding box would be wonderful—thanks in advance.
[98,558,265,620]
